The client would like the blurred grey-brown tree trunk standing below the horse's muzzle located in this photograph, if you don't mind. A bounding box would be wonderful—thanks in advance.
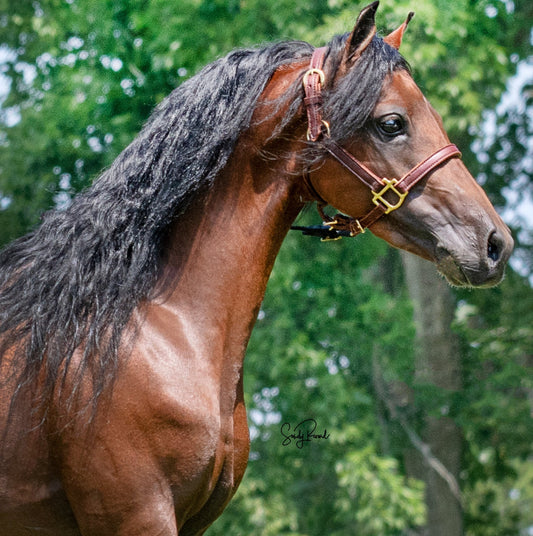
[402,254,463,536]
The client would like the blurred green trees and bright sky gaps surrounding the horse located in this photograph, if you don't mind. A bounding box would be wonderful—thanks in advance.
[0,0,533,536]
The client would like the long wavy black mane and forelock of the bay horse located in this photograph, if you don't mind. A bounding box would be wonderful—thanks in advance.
[0,36,405,416]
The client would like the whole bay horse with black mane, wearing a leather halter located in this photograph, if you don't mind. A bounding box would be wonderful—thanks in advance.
[0,2,512,536]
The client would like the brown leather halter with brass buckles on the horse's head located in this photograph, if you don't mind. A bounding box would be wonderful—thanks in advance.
[300,47,461,239]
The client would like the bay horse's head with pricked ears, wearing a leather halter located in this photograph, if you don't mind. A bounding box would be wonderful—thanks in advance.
[304,2,513,287]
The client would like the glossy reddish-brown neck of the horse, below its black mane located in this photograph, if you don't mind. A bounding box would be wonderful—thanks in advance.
[153,137,303,362]
